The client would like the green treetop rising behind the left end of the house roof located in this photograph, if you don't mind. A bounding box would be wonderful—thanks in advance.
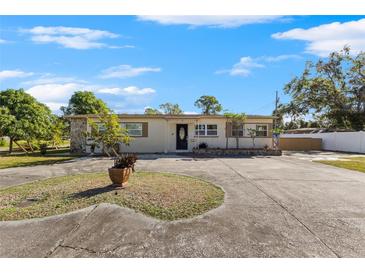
[61,91,108,115]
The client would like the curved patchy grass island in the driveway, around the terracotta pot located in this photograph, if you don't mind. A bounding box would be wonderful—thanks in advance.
[0,172,224,221]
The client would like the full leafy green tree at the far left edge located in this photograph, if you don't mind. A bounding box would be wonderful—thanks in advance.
[0,89,54,153]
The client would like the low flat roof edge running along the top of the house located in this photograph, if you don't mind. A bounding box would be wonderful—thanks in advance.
[65,114,277,119]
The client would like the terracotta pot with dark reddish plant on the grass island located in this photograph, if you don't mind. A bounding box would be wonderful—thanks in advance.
[108,154,137,188]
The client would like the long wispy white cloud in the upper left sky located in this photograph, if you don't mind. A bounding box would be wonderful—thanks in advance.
[21,26,119,49]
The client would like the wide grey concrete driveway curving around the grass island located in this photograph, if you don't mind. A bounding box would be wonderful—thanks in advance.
[0,156,365,257]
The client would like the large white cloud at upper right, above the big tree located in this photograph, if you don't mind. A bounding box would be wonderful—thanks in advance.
[272,18,365,57]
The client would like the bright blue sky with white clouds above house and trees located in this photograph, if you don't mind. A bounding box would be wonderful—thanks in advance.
[0,16,365,114]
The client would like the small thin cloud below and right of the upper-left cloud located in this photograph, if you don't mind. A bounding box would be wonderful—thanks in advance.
[100,65,161,79]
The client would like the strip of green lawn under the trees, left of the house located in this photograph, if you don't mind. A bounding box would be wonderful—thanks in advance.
[0,149,77,169]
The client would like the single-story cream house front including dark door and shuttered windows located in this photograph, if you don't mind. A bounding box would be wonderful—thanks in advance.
[67,114,274,153]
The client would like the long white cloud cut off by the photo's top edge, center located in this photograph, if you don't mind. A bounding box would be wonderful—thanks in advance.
[138,15,282,28]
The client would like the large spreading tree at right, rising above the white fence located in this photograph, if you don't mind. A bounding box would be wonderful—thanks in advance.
[281,47,365,130]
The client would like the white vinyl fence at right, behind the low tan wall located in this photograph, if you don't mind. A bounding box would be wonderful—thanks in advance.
[280,131,365,153]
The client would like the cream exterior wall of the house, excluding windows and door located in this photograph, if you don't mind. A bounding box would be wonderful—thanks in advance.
[71,116,272,153]
